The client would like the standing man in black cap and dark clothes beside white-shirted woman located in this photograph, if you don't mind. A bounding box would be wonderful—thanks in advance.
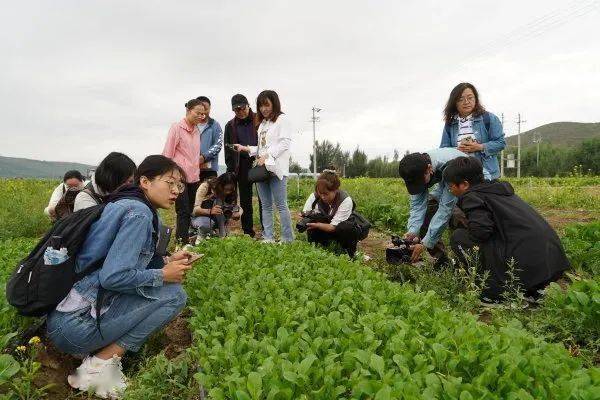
[224,94,262,237]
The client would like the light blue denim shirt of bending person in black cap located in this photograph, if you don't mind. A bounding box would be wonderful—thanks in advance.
[408,148,466,249]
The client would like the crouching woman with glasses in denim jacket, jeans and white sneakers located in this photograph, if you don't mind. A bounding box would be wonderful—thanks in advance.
[47,155,196,398]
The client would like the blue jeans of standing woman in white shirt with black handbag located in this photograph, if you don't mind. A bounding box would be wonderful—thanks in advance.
[256,176,294,242]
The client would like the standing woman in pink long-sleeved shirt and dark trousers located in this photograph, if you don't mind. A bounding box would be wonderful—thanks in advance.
[163,99,206,244]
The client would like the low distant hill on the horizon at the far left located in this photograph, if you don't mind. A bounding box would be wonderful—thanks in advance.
[0,156,94,179]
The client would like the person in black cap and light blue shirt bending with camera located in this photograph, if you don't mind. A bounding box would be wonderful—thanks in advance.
[398,148,466,265]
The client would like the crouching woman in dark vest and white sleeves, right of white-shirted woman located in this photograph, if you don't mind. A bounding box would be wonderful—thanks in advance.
[297,169,360,257]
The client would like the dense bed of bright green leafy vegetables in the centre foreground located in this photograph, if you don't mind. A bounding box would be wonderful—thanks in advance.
[124,238,600,399]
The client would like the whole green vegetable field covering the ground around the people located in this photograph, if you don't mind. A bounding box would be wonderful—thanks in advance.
[0,177,600,400]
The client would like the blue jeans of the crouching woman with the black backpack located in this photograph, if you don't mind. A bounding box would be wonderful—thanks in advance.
[47,283,187,355]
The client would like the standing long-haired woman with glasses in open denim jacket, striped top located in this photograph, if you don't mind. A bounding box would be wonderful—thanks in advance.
[440,83,506,180]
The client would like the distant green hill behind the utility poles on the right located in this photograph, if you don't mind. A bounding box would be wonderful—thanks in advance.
[506,122,600,147]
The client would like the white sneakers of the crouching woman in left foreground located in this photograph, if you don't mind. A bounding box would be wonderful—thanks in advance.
[67,356,127,399]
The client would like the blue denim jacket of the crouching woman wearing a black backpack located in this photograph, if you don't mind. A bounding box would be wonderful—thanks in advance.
[73,199,163,312]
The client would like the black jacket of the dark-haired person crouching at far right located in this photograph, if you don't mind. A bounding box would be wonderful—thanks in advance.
[458,181,569,296]
